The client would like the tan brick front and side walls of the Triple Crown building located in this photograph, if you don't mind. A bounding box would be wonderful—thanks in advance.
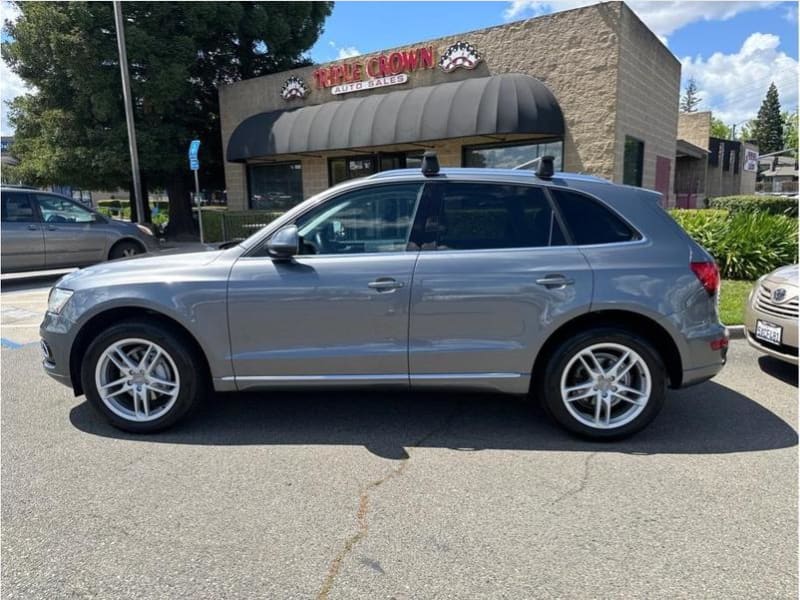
[220,2,680,206]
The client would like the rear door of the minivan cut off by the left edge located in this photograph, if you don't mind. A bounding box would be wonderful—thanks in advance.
[0,192,44,271]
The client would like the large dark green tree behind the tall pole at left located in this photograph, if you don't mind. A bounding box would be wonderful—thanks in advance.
[2,2,332,235]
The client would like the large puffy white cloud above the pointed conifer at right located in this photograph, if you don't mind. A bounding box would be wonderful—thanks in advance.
[681,33,798,125]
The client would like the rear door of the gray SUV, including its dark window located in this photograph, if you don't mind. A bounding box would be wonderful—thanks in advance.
[409,182,592,393]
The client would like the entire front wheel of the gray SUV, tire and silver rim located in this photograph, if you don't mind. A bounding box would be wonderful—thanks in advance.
[81,321,208,433]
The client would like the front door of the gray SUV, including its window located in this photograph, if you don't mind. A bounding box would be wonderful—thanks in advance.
[228,183,423,389]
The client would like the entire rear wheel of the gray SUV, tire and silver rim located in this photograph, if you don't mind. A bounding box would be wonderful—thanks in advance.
[536,327,667,441]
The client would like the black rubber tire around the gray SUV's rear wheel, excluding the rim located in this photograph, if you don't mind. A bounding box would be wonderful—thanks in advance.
[538,328,667,441]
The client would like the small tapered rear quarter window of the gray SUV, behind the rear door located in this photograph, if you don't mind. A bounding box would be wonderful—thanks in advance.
[550,189,639,246]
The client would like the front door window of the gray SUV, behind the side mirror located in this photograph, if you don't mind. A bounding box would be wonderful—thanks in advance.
[295,183,422,255]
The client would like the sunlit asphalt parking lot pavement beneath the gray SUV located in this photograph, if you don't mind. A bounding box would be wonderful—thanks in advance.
[0,282,798,600]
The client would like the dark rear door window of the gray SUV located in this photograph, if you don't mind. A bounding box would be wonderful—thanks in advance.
[425,183,564,250]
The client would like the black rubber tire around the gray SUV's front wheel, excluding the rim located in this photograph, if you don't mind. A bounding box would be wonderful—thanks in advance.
[81,321,204,433]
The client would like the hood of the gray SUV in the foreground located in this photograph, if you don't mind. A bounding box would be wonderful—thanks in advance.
[56,250,230,290]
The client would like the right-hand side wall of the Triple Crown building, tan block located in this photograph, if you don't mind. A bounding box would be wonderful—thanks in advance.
[614,4,681,205]
